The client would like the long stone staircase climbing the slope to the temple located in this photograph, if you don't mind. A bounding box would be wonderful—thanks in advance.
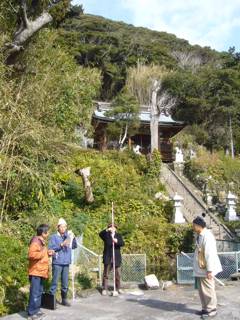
[161,164,235,240]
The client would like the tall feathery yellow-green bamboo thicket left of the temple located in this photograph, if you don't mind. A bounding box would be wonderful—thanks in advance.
[0,29,100,223]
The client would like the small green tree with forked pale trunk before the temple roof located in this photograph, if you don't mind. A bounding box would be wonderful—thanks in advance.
[107,90,140,148]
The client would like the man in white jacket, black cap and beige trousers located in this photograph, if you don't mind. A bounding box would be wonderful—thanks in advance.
[193,216,222,319]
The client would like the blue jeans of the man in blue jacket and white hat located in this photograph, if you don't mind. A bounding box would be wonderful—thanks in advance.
[49,264,69,299]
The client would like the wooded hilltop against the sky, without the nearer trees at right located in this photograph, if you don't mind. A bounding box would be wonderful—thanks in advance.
[59,14,221,99]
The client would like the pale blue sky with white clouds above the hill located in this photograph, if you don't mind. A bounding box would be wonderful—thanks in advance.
[73,0,240,51]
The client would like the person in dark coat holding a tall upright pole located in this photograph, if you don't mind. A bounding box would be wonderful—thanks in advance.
[99,219,124,296]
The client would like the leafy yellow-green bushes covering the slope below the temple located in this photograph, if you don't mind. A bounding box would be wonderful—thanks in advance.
[0,151,191,314]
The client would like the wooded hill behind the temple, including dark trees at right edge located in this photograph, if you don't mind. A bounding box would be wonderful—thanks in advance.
[58,14,240,152]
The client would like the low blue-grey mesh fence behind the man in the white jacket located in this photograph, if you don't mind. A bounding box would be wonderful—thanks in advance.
[177,251,240,284]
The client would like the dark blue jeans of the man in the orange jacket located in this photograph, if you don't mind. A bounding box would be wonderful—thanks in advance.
[28,276,44,316]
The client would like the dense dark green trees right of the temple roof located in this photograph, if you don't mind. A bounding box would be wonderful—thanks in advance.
[163,66,240,151]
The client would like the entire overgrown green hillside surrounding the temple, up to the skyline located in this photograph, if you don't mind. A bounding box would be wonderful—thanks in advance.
[0,0,240,315]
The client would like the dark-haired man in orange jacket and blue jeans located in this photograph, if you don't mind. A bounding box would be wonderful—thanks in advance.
[28,224,54,320]
